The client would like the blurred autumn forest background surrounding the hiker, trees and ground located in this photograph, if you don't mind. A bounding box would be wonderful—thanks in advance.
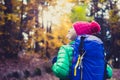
[0,0,120,80]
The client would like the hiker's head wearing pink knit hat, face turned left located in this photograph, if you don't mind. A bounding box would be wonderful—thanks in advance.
[67,21,101,40]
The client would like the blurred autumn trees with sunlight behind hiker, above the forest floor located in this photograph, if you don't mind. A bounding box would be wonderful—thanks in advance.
[0,0,120,68]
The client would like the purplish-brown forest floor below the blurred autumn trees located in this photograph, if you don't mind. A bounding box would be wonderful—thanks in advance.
[0,55,120,80]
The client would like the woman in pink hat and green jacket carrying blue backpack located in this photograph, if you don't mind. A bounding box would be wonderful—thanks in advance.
[52,21,111,80]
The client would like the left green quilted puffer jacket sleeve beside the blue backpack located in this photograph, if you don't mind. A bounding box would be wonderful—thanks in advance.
[52,45,73,78]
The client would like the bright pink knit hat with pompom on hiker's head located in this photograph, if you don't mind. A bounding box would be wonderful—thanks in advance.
[73,21,101,35]
